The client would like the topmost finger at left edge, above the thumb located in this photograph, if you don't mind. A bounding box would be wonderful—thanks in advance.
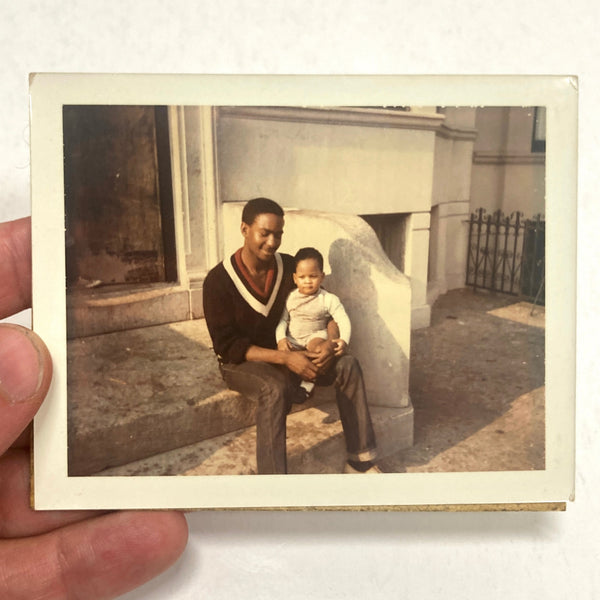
[0,217,31,319]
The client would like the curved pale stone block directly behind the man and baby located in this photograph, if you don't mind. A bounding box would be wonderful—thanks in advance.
[223,202,411,408]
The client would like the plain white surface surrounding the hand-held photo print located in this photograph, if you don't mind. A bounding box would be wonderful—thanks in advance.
[0,0,600,600]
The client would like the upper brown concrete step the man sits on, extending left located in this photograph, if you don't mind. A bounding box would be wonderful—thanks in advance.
[67,320,350,476]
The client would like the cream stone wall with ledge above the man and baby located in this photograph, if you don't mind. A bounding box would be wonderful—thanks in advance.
[215,107,444,328]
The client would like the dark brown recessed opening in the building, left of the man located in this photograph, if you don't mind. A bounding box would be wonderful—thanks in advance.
[63,106,177,289]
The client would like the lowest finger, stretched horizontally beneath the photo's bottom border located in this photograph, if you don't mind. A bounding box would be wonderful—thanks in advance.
[0,511,187,600]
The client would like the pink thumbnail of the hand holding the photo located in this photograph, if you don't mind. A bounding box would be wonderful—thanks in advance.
[0,323,43,404]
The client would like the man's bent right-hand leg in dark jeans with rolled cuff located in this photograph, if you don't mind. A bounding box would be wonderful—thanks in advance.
[317,354,377,466]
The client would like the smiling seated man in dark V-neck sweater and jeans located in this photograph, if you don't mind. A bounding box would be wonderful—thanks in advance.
[203,198,378,474]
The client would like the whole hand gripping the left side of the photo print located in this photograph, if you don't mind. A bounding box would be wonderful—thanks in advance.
[0,219,187,600]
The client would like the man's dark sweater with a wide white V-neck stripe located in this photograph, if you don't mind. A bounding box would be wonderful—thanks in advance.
[203,250,295,363]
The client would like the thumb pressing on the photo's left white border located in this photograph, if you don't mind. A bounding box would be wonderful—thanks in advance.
[0,323,52,454]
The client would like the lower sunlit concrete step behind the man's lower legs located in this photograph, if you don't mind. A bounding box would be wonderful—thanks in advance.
[97,403,413,476]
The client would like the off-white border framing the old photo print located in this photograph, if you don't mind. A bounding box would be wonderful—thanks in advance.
[30,74,578,510]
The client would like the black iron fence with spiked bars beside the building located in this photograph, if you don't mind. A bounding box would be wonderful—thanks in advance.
[466,208,546,304]
